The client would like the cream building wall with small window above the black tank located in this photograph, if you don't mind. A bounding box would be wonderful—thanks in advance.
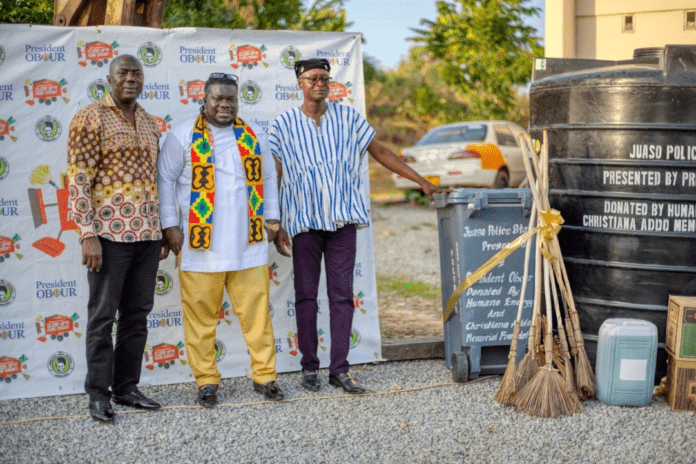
[544,0,696,60]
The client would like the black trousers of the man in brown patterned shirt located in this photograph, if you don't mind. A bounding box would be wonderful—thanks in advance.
[85,237,160,400]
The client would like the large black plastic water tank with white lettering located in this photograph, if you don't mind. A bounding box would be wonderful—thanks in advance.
[529,45,696,379]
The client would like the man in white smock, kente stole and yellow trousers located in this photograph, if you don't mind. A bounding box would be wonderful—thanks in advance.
[157,73,283,407]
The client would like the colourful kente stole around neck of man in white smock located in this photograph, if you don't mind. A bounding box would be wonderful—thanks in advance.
[189,114,265,250]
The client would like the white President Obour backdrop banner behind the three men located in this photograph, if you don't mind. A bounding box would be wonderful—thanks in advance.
[0,24,382,400]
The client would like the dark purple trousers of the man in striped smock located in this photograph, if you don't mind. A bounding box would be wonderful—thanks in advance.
[292,224,356,374]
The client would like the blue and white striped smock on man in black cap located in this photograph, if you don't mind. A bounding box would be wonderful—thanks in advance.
[270,102,375,237]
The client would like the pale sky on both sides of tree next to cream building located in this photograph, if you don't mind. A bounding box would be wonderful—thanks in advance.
[344,0,544,69]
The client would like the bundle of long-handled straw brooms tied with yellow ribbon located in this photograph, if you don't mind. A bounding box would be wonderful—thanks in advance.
[495,131,596,418]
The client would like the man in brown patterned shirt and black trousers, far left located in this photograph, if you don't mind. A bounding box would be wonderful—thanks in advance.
[68,55,168,422]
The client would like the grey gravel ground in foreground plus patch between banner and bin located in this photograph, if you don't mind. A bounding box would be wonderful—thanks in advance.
[0,205,696,463]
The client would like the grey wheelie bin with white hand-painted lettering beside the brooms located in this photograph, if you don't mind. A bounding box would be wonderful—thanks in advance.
[435,189,535,382]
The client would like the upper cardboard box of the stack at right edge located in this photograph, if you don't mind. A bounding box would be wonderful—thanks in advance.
[665,295,696,361]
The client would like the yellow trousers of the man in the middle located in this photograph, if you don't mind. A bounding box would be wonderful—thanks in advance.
[179,264,276,386]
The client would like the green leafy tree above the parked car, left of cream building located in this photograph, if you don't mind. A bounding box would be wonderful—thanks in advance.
[412,0,543,119]
